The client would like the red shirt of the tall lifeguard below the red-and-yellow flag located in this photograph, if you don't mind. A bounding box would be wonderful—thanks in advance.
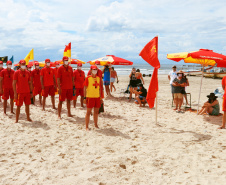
[57,65,73,89]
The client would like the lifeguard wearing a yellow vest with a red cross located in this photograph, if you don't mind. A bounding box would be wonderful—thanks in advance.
[84,65,103,131]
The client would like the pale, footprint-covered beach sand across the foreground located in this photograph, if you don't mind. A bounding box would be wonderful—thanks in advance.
[0,75,226,185]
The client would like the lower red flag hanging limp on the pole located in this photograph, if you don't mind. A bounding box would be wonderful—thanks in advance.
[146,68,159,108]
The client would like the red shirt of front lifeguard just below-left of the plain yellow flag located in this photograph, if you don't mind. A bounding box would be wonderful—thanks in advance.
[13,69,31,93]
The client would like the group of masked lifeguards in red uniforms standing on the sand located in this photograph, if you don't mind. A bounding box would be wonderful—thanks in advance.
[0,57,103,130]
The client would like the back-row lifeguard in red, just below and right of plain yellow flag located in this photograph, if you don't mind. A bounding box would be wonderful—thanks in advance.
[31,61,42,105]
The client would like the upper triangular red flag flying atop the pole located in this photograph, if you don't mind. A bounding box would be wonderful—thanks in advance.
[139,37,160,68]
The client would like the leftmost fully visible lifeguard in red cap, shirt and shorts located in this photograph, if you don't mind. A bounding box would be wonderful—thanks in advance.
[0,60,14,114]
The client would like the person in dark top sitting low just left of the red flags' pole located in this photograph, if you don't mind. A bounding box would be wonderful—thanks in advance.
[133,83,147,107]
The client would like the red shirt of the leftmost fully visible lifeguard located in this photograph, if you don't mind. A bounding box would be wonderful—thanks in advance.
[0,69,15,89]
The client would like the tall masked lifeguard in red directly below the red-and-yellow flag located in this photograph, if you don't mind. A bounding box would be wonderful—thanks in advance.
[57,56,75,119]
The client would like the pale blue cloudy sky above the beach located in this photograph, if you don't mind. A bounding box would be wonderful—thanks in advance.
[0,0,226,64]
